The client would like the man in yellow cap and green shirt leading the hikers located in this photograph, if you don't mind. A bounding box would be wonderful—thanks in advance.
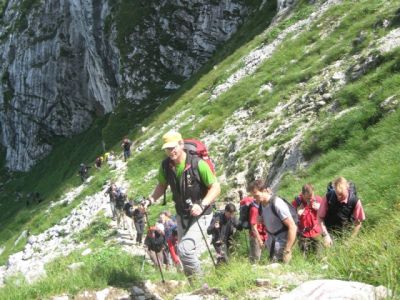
[144,131,220,278]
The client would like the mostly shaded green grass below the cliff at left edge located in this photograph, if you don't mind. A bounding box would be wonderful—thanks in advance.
[0,120,111,263]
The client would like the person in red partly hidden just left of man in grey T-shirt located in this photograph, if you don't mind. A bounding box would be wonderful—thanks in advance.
[245,197,268,264]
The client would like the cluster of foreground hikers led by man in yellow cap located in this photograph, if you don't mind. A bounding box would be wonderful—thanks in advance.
[102,131,365,279]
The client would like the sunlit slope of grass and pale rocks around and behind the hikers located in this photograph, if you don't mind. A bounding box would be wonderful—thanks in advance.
[0,0,400,298]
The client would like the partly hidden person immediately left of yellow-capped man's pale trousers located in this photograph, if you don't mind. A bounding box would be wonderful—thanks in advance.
[159,211,182,271]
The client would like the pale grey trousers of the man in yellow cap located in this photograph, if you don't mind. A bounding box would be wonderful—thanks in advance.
[176,214,212,276]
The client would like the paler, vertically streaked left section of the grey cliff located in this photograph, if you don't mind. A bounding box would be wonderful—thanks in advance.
[0,0,119,171]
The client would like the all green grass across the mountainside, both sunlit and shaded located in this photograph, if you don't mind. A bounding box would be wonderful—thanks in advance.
[0,0,400,299]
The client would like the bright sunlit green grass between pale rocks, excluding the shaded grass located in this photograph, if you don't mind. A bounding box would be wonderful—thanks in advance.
[0,1,400,299]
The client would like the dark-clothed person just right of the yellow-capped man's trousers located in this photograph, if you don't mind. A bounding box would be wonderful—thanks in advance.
[207,203,238,264]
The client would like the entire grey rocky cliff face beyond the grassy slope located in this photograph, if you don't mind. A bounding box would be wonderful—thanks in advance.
[0,0,262,171]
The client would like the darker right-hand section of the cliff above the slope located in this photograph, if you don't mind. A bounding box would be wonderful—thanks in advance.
[122,0,249,102]
